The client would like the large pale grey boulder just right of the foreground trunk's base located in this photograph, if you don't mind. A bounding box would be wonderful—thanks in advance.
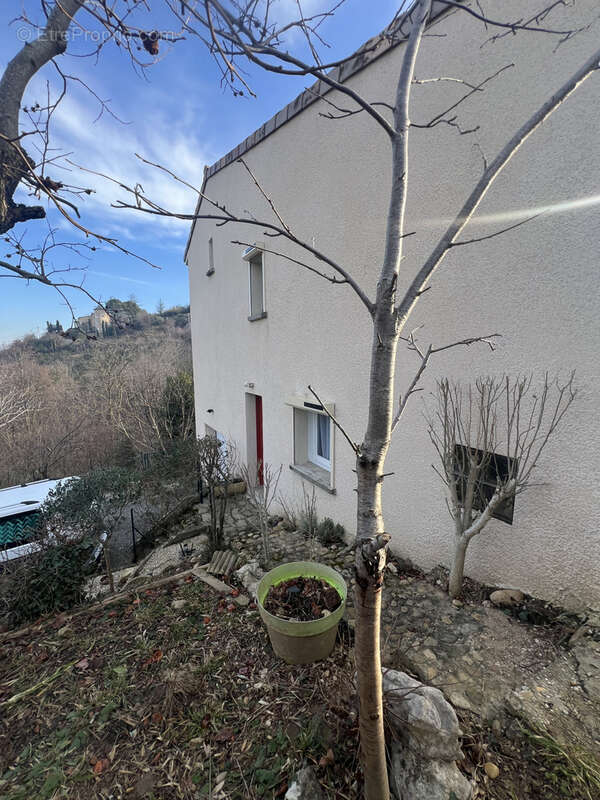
[383,670,463,761]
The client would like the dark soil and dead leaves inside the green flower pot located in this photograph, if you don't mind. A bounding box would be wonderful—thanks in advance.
[264,577,342,622]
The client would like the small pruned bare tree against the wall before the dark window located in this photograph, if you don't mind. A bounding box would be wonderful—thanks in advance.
[429,373,575,598]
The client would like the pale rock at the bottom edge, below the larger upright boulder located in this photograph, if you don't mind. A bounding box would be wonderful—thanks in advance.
[390,742,471,800]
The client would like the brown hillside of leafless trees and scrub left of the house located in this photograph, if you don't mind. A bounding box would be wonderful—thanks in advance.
[0,298,194,487]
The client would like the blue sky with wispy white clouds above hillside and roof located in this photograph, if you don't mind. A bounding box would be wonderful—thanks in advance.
[0,0,397,344]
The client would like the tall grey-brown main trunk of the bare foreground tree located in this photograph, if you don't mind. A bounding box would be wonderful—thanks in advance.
[354,7,431,800]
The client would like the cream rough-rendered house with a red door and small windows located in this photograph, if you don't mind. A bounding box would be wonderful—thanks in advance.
[186,0,600,607]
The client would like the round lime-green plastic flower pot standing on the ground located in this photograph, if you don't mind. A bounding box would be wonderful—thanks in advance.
[257,561,348,664]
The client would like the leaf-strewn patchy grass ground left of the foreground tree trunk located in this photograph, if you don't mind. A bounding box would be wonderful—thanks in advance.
[0,582,360,800]
